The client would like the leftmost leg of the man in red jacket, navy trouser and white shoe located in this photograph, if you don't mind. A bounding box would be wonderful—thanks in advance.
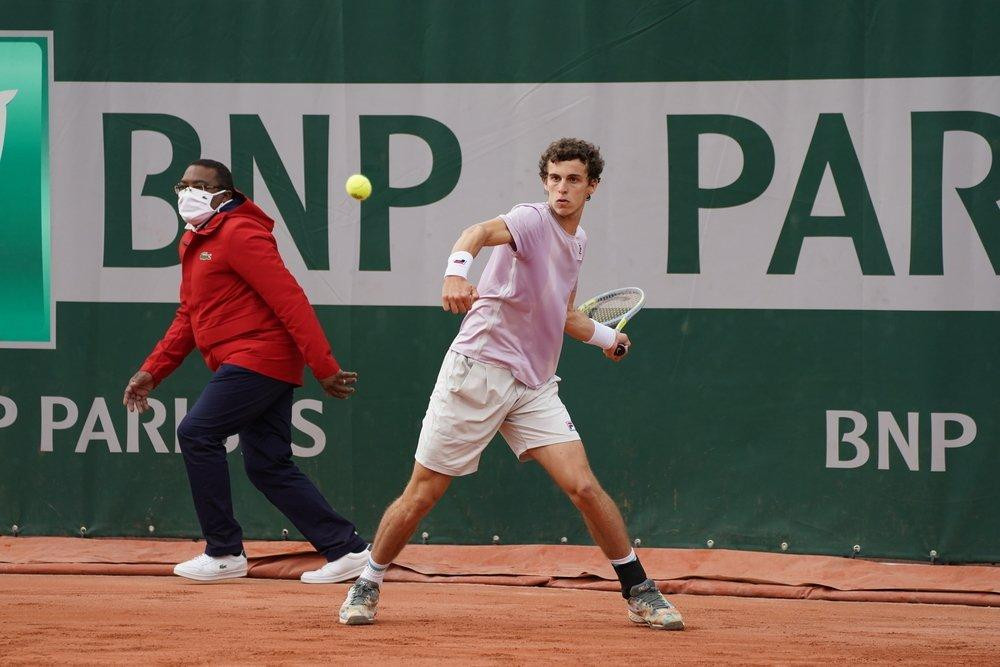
[174,364,287,581]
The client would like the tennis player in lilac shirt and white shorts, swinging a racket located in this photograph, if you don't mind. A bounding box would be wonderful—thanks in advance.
[340,139,684,630]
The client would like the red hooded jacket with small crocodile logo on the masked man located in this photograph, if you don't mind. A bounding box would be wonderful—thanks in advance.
[142,199,340,385]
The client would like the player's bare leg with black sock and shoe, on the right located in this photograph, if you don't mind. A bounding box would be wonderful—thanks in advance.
[528,440,684,630]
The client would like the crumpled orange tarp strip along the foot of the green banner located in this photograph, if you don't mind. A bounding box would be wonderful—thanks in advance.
[0,537,1000,607]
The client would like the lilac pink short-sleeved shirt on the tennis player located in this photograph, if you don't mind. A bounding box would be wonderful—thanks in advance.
[451,203,587,388]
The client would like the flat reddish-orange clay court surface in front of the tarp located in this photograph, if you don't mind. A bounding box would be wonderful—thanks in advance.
[0,574,1000,665]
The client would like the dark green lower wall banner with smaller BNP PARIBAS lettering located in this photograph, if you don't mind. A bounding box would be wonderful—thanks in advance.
[0,304,1000,561]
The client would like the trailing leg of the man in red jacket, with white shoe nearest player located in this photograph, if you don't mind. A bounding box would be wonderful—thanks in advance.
[240,380,368,583]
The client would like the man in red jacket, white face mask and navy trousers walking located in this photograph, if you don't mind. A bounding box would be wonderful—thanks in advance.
[123,160,368,583]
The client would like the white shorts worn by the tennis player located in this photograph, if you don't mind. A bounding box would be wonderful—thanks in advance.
[414,350,580,477]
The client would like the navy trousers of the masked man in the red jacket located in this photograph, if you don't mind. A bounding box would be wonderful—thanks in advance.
[177,364,367,561]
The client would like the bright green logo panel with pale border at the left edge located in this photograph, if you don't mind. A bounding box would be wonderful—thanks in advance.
[0,32,55,347]
